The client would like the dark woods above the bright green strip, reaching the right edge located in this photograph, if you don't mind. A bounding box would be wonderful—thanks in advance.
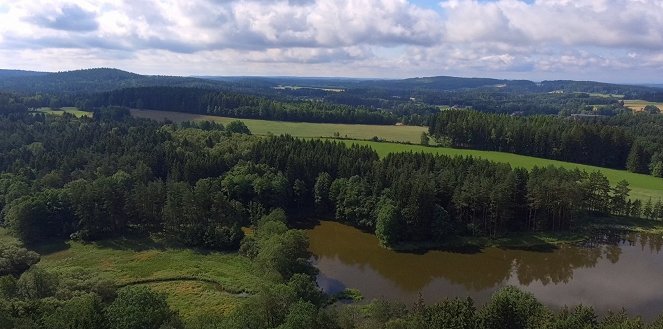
[429,110,663,177]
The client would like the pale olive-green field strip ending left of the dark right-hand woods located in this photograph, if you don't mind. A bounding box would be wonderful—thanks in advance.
[131,110,428,143]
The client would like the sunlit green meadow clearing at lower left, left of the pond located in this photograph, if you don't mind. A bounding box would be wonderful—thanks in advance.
[32,236,263,321]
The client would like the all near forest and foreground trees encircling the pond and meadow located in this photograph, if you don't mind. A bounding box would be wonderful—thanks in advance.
[0,111,663,329]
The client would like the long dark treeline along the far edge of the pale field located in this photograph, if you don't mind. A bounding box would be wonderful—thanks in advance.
[86,87,398,124]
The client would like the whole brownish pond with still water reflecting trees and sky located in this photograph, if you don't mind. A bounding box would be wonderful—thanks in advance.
[307,221,663,320]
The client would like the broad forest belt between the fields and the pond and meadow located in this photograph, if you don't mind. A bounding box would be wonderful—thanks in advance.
[0,113,659,250]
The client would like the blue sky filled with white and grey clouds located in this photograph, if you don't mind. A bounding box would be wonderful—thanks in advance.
[0,0,663,83]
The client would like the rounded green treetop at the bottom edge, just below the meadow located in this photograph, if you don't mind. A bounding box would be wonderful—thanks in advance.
[105,287,183,329]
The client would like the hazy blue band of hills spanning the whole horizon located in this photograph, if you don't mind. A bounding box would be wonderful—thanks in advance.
[0,68,663,101]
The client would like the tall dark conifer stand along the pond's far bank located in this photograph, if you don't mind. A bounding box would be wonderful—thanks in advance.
[252,137,659,245]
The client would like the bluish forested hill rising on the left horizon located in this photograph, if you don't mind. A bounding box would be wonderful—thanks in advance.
[0,68,227,94]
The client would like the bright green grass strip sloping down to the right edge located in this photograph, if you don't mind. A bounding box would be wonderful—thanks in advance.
[345,140,663,202]
